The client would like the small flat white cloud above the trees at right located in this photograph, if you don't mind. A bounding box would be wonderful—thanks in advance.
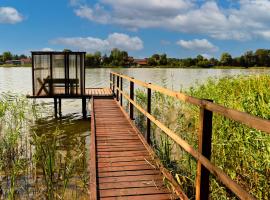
[177,39,218,52]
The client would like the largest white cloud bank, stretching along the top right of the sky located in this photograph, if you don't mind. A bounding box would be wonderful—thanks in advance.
[71,0,270,40]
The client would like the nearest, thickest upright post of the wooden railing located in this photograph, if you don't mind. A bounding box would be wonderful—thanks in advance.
[196,100,213,200]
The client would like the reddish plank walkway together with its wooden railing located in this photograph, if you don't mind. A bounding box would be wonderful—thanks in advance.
[90,73,270,200]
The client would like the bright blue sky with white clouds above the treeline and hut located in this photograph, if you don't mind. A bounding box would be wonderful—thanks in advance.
[0,0,270,58]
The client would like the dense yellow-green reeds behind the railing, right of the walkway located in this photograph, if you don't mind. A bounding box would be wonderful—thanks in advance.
[136,75,270,199]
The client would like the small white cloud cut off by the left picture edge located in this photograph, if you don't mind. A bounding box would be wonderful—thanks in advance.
[0,7,23,24]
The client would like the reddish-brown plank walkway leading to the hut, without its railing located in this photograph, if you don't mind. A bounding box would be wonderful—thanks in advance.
[90,99,175,200]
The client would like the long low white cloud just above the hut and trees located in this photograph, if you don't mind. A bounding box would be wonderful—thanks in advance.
[51,33,143,52]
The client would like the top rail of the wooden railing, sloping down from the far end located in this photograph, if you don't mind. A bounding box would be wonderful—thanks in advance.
[111,72,270,133]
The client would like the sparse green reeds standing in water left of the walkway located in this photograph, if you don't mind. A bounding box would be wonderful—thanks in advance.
[0,93,89,199]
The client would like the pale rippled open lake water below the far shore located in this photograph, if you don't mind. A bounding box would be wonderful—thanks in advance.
[0,67,270,117]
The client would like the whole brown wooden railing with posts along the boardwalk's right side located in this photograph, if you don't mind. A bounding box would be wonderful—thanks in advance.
[110,72,270,200]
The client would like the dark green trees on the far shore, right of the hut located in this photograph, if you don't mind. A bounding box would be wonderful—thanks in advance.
[85,49,270,68]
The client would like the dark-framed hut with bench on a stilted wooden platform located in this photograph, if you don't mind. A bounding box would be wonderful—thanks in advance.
[28,51,113,118]
